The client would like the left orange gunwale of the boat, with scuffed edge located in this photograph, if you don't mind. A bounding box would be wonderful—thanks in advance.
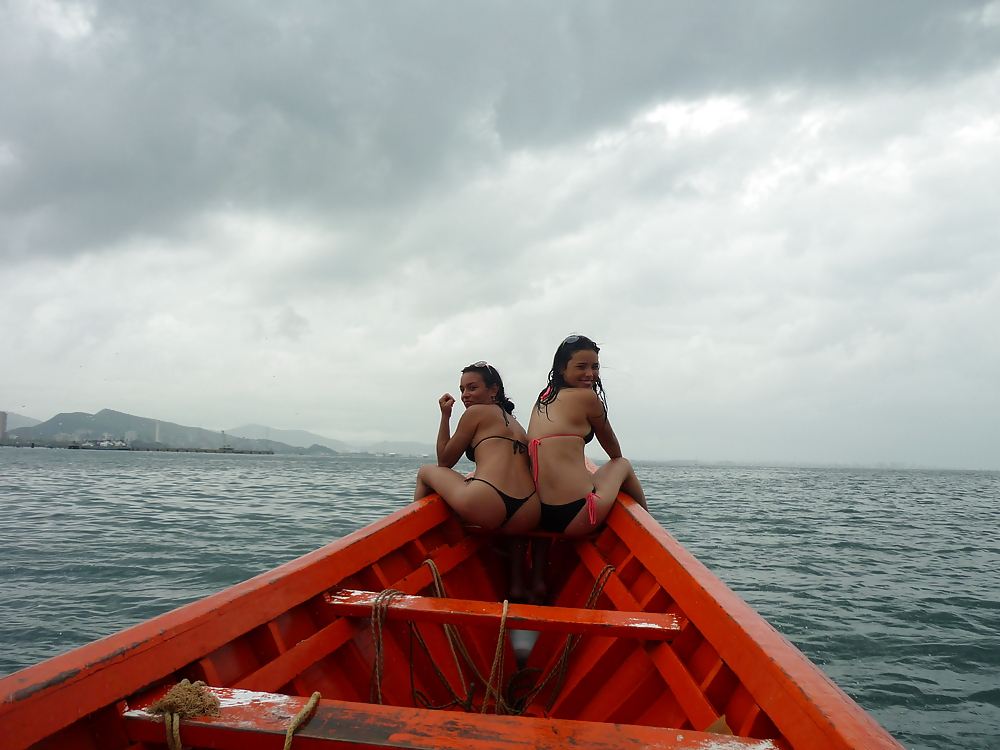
[0,495,452,750]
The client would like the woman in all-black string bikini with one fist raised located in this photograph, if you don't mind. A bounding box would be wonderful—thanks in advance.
[414,362,541,534]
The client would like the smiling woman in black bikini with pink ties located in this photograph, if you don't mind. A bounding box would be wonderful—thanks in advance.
[528,336,646,536]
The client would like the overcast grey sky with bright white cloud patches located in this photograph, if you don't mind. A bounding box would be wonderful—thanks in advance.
[0,0,1000,469]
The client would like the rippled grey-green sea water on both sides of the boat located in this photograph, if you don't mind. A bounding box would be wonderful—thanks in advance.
[0,448,1000,750]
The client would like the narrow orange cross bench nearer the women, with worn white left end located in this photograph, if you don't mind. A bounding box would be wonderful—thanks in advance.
[326,590,681,641]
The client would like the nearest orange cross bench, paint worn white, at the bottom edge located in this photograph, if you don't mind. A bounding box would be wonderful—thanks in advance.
[125,688,774,750]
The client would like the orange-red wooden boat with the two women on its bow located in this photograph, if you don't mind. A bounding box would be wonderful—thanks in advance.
[0,495,901,750]
